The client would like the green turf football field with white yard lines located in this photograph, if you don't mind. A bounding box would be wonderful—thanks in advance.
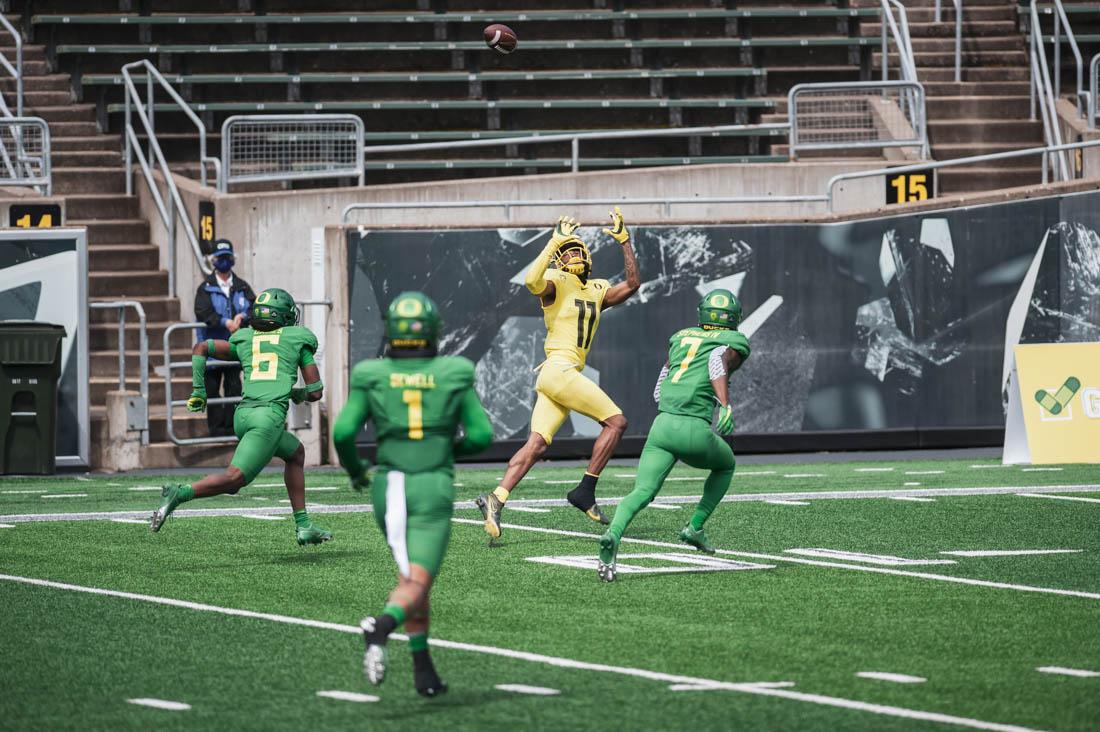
[0,460,1100,730]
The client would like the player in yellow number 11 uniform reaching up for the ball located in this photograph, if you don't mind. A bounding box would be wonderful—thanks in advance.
[476,207,641,538]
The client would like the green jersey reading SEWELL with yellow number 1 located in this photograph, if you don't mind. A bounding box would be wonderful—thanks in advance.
[351,356,474,473]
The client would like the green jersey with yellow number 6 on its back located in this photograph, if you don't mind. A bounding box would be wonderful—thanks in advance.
[229,326,317,415]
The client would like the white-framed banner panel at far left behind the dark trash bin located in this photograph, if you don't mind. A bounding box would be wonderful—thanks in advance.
[0,229,89,467]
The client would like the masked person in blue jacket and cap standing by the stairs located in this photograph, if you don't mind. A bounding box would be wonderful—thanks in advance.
[195,239,256,437]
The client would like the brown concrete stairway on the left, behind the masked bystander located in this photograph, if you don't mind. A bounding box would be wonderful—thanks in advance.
[0,15,226,468]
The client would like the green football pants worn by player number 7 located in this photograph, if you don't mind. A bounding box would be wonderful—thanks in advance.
[611,412,737,538]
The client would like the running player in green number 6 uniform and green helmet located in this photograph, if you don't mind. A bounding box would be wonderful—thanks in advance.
[152,288,332,546]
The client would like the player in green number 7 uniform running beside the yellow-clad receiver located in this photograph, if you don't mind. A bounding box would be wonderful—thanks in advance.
[597,289,749,582]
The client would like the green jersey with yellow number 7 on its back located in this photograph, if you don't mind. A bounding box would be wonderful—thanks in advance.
[658,327,749,422]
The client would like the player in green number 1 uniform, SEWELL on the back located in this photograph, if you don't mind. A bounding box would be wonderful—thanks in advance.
[332,292,493,697]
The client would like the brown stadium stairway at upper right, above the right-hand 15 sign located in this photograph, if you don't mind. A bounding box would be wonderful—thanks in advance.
[862,0,1038,194]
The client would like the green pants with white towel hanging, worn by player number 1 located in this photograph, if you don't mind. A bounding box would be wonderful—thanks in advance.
[371,467,454,577]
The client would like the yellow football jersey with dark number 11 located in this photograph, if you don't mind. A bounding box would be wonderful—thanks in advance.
[542,270,611,367]
